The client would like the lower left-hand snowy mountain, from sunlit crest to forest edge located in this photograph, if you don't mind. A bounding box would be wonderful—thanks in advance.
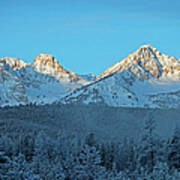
[0,54,89,106]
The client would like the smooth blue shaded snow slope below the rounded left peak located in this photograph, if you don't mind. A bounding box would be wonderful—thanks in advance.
[15,66,66,104]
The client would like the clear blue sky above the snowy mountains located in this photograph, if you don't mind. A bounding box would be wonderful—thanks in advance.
[0,0,180,74]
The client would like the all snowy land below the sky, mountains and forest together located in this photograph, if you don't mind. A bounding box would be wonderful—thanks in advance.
[0,45,180,180]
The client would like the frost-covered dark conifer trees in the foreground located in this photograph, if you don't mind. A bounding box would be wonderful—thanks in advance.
[0,118,180,180]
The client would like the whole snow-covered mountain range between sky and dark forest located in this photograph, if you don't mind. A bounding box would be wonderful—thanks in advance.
[0,45,180,108]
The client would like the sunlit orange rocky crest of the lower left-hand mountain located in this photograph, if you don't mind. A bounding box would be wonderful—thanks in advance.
[0,53,88,86]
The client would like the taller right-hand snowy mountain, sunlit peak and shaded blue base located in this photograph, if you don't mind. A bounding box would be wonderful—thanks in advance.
[62,45,180,108]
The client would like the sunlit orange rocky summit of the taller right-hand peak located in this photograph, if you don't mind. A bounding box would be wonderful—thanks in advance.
[98,45,180,80]
